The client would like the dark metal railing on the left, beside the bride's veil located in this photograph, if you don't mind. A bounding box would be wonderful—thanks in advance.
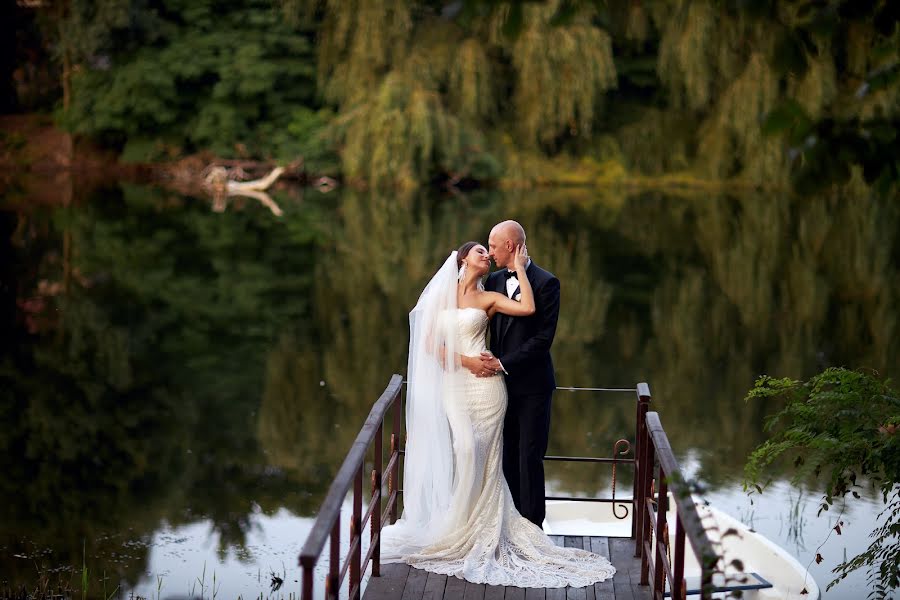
[299,375,403,600]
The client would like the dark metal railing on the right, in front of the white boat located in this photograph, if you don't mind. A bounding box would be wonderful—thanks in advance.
[633,406,719,600]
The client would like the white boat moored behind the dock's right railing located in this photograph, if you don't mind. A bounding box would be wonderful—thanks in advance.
[544,496,821,600]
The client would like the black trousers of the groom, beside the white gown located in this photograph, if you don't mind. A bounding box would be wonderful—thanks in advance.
[503,392,553,527]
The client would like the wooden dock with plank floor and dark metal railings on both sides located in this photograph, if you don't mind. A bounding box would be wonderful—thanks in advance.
[299,382,722,600]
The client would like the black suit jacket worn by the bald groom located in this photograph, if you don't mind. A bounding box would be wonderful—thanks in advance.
[485,261,559,396]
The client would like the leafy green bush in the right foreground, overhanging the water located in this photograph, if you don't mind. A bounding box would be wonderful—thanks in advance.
[746,368,900,598]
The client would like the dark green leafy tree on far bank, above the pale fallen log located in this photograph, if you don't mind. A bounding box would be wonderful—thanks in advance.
[68,0,315,160]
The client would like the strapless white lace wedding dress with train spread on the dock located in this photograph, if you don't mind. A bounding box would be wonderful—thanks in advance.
[383,308,615,588]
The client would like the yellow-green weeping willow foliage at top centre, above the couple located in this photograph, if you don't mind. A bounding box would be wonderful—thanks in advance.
[283,0,616,187]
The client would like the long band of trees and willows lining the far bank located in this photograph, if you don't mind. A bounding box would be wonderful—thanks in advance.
[12,0,900,192]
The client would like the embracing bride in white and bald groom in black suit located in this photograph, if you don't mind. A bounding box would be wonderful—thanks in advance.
[381,221,615,588]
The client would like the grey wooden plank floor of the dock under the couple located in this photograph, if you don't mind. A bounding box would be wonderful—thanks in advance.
[363,536,650,600]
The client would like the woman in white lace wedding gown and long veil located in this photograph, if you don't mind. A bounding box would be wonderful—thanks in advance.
[381,242,615,588]
